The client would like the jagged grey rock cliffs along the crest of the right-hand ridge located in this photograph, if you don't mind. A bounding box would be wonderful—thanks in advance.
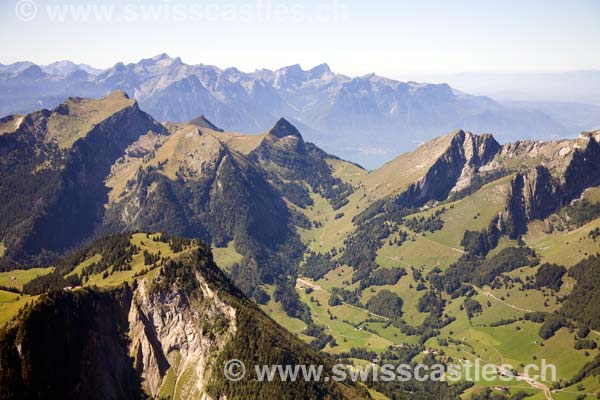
[382,131,600,238]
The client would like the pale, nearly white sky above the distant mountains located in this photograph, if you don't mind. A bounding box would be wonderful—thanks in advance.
[0,0,600,78]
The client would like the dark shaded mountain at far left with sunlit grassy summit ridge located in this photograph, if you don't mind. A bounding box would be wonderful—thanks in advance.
[0,93,166,264]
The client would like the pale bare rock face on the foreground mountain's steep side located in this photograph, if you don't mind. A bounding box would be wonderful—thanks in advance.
[128,272,236,399]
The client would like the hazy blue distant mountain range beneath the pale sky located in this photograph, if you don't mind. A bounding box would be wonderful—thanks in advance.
[0,54,576,167]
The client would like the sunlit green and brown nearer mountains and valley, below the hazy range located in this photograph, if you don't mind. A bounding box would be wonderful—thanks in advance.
[0,92,600,400]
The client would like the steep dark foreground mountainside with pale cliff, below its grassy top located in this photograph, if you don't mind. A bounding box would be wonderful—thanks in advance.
[0,239,368,399]
